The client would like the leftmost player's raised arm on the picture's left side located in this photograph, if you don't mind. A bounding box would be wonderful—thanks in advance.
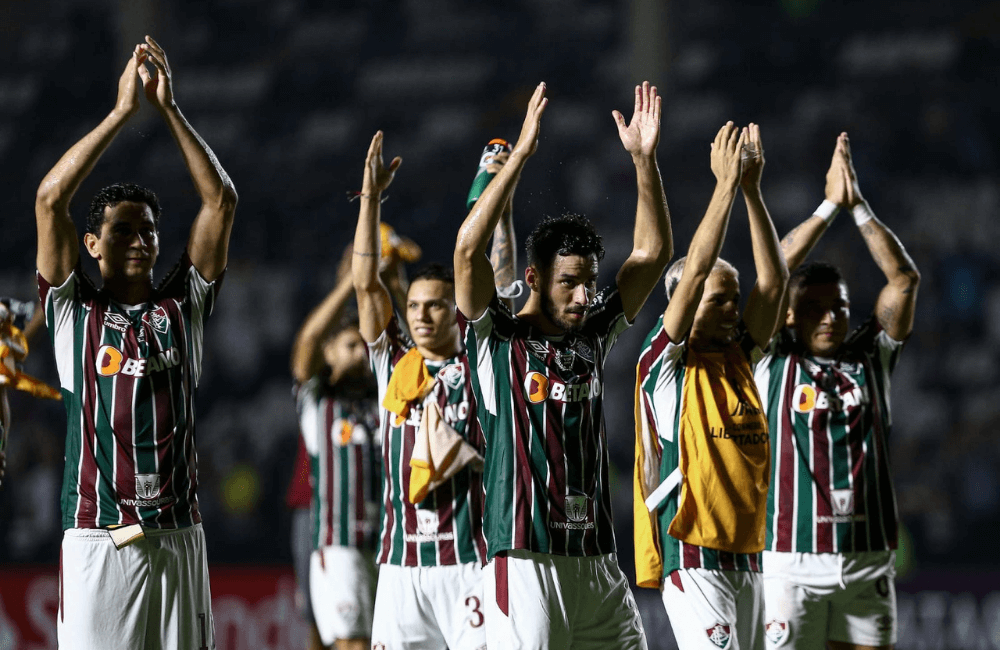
[35,46,145,285]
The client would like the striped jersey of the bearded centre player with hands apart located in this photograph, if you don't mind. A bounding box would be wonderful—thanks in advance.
[466,289,629,558]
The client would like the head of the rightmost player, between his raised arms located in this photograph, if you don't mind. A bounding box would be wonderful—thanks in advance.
[785,282,851,357]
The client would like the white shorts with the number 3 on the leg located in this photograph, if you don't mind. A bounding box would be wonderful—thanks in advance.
[372,562,486,650]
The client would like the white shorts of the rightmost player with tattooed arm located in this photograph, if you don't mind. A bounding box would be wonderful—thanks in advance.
[764,551,896,650]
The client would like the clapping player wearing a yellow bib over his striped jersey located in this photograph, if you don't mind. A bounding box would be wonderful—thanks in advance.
[634,122,788,650]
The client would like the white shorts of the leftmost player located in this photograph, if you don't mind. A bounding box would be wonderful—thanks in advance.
[57,524,215,650]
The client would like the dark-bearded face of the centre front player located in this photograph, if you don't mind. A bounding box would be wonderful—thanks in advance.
[539,255,597,332]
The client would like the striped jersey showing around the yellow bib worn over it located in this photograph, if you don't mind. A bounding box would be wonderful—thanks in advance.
[638,316,761,577]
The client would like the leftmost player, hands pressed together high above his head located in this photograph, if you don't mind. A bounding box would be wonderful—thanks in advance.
[35,36,237,650]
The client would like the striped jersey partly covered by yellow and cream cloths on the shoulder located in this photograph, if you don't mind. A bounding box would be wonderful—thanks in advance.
[368,316,486,566]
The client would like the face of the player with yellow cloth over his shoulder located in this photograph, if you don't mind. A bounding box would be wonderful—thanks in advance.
[406,278,461,359]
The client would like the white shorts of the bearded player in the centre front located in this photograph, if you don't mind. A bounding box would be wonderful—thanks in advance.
[483,550,647,650]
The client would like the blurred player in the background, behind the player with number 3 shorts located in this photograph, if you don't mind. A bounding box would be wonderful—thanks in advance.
[292,247,381,650]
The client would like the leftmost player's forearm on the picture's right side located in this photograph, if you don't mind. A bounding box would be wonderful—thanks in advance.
[161,104,238,210]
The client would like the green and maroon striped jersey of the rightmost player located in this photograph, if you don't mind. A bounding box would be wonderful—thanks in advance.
[754,316,903,553]
